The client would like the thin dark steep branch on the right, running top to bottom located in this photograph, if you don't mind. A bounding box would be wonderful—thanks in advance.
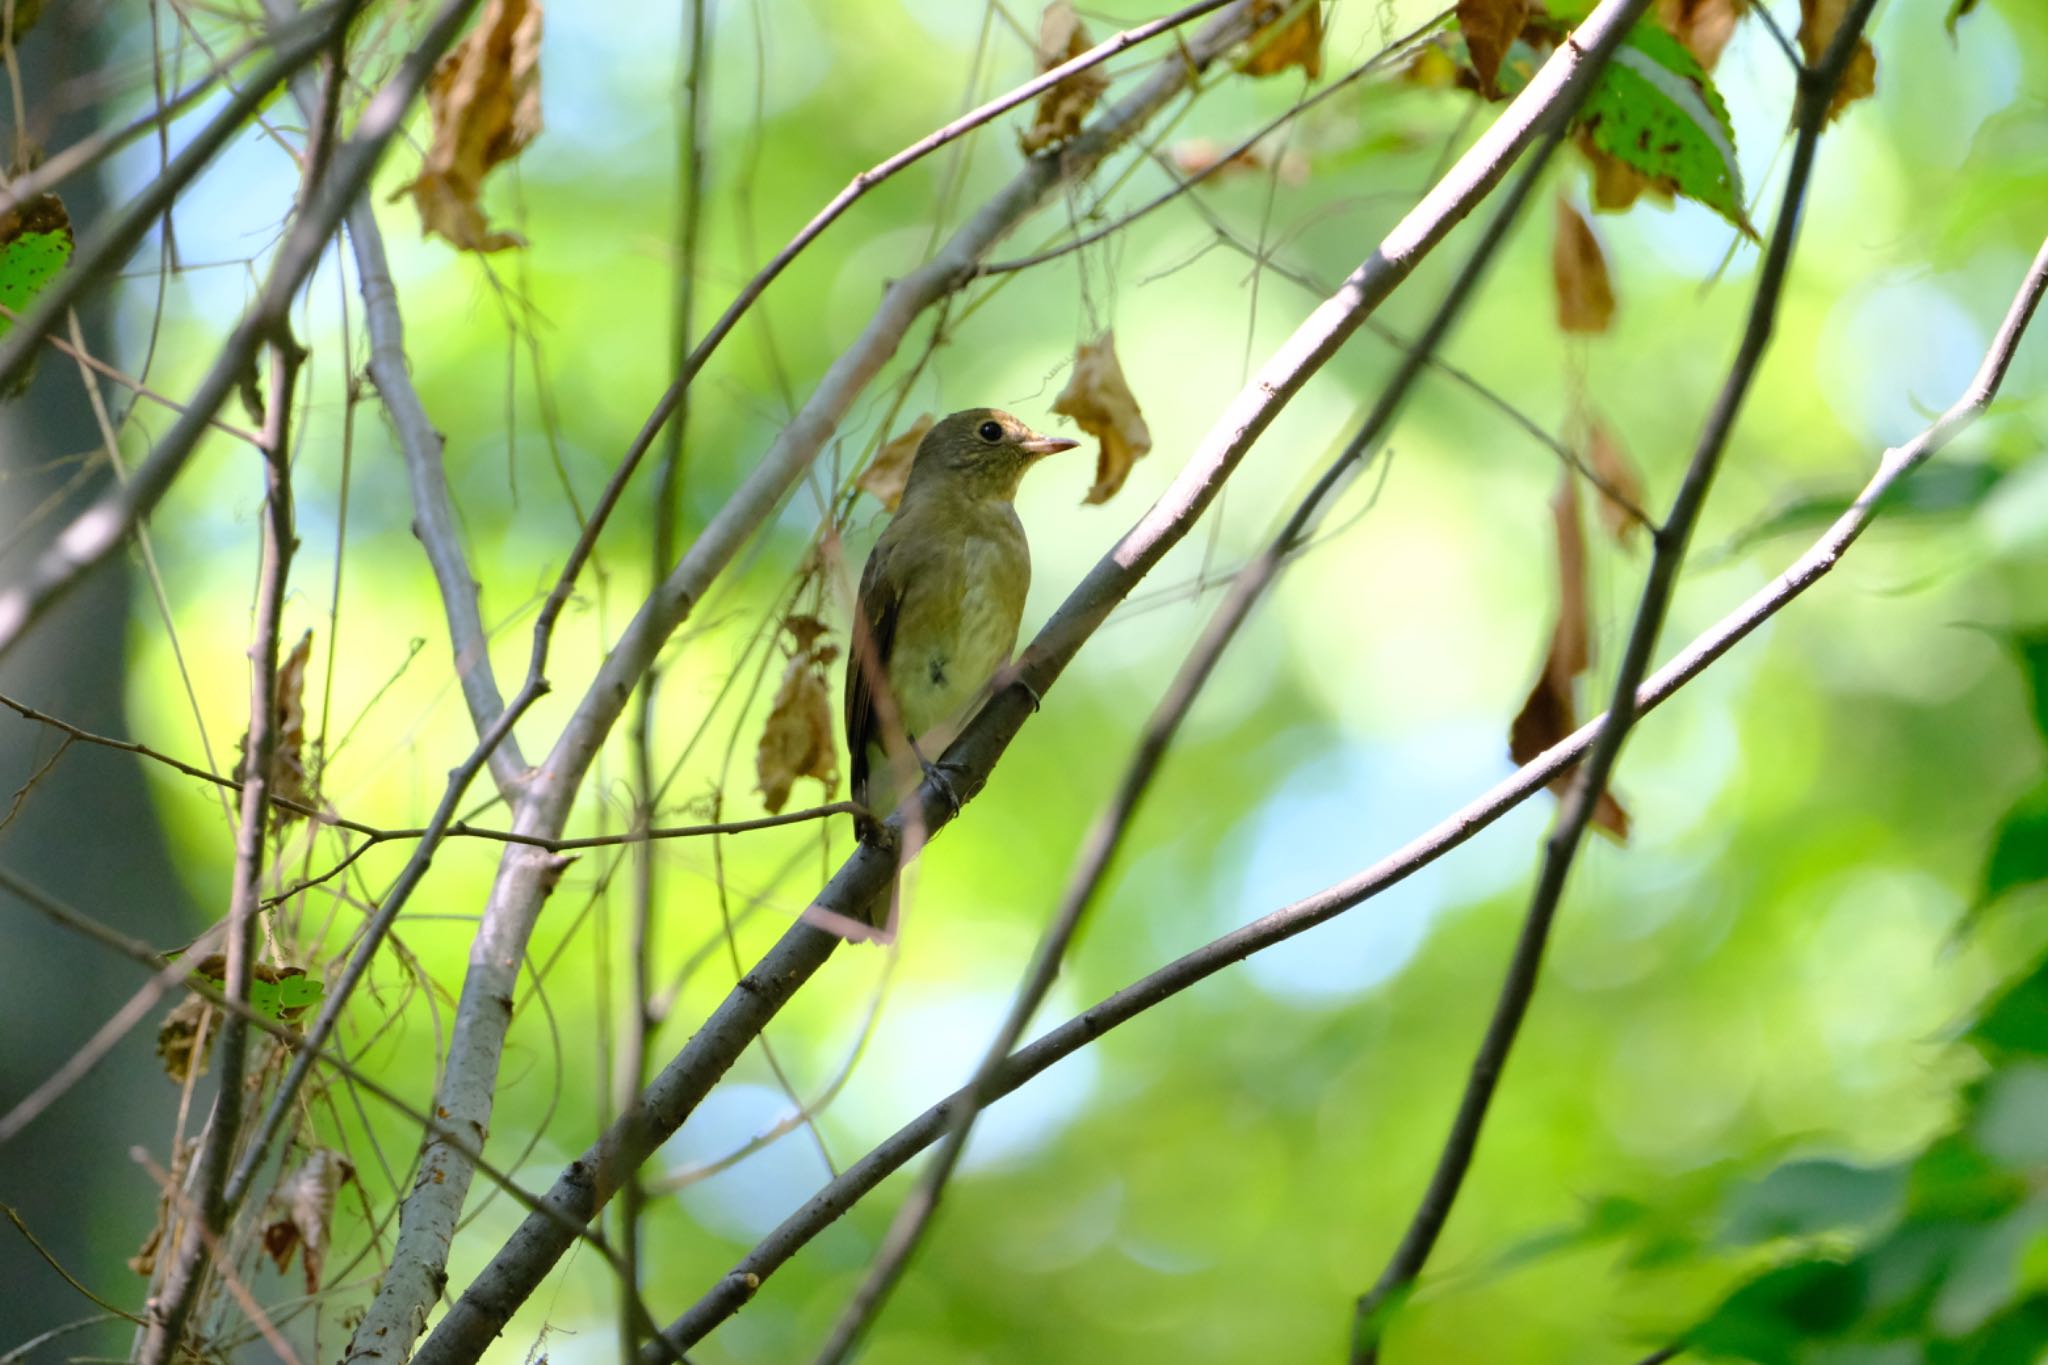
[1352,0,1876,1365]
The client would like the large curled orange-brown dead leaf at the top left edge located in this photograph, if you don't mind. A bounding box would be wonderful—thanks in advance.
[399,0,541,252]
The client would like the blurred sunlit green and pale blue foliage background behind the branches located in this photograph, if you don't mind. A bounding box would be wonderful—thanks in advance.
[12,0,2048,1363]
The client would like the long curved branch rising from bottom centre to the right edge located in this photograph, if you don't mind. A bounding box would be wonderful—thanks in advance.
[639,229,2048,1365]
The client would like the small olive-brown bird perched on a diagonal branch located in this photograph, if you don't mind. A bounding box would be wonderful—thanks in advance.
[846,407,1079,834]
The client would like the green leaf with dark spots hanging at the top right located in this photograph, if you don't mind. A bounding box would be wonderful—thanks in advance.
[1577,25,1757,239]
